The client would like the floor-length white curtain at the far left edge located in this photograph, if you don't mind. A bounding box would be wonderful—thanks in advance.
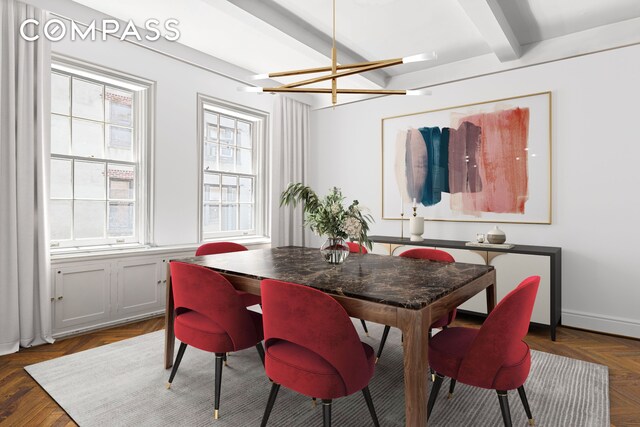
[0,0,53,354]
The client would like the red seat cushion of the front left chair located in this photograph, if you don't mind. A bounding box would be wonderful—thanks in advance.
[174,310,263,353]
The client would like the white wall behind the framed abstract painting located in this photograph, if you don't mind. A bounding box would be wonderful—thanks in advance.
[310,46,640,337]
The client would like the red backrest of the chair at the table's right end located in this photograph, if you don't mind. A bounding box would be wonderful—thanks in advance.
[458,276,540,388]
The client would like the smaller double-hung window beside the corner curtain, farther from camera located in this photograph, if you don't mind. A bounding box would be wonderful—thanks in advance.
[198,95,268,240]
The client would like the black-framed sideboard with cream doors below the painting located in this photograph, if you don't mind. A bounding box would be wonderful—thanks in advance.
[370,236,561,340]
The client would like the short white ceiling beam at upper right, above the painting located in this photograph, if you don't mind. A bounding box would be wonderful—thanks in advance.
[458,0,522,62]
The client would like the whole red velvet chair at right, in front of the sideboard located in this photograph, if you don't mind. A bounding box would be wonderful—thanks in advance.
[427,276,540,426]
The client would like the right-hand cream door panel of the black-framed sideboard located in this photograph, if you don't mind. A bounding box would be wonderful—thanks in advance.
[489,252,551,325]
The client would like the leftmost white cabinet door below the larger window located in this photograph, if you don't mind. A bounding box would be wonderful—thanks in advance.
[53,263,110,330]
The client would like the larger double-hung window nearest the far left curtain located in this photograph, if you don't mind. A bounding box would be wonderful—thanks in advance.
[49,61,152,248]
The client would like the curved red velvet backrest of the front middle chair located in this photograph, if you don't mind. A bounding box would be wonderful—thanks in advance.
[260,279,367,394]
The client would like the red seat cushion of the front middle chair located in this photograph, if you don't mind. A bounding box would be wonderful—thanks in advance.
[265,340,375,399]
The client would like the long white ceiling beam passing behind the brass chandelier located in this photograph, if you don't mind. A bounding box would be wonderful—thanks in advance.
[229,0,391,88]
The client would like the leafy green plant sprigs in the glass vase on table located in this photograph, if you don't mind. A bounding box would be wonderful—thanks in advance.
[280,183,373,249]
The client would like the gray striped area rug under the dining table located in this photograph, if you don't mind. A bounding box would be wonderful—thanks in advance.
[25,322,609,427]
